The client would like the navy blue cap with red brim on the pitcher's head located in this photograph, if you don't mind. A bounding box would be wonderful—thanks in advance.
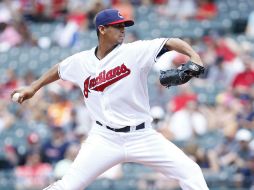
[95,9,134,28]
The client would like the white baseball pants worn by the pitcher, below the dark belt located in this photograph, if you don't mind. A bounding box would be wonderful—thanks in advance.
[44,125,208,190]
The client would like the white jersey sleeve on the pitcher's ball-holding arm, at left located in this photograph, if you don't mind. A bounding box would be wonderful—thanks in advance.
[58,54,79,83]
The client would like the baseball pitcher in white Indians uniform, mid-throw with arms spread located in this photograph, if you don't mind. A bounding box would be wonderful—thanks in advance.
[12,9,208,190]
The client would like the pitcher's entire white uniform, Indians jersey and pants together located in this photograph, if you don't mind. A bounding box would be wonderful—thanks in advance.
[45,39,208,190]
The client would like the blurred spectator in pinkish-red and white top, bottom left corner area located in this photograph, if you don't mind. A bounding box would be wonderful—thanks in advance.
[15,150,52,190]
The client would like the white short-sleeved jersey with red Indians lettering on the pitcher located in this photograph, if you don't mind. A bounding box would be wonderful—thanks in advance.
[58,38,167,128]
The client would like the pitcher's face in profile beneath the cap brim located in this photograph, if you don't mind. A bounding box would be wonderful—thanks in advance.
[106,23,125,44]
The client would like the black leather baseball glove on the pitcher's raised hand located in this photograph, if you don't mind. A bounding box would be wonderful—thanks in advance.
[160,61,205,87]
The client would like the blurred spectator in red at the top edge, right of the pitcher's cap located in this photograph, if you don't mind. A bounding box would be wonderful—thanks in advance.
[195,0,218,20]
